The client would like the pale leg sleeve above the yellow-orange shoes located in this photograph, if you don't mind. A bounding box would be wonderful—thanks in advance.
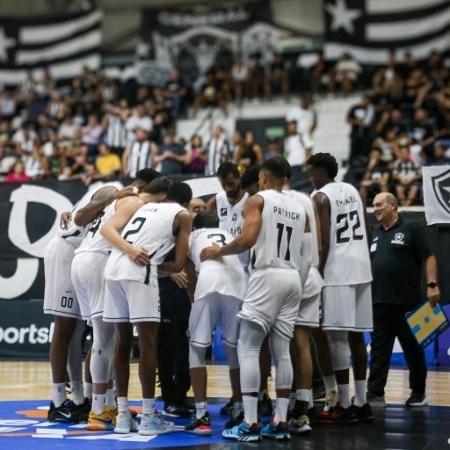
[90,318,115,383]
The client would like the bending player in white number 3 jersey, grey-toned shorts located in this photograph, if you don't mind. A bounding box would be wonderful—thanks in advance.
[185,212,246,436]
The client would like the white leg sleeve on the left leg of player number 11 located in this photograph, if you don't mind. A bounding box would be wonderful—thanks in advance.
[237,320,265,394]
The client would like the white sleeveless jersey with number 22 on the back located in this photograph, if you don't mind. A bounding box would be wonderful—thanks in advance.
[315,183,372,286]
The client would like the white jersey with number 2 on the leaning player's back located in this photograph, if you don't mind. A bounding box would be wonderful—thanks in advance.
[105,203,186,283]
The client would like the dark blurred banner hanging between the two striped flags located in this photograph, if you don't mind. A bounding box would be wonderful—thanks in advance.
[137,0,295,84]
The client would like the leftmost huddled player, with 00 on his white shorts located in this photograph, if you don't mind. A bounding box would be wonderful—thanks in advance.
[44,180,133,423]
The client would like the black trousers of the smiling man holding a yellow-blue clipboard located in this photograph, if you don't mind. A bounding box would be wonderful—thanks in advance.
[367,303,427,396]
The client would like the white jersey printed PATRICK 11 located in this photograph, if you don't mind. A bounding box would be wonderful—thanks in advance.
[250,190,306,271]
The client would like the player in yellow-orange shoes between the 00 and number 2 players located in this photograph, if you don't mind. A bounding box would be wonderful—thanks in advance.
[71,169,159,431]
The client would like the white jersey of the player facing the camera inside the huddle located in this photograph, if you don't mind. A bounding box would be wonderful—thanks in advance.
[216,191,250,268]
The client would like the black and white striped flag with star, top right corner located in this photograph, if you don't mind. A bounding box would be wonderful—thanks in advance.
[324,0,450,64]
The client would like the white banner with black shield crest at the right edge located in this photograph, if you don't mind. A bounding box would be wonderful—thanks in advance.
[422,165,450,225]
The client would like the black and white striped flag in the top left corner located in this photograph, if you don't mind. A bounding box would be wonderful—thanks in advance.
[0,10,102,84]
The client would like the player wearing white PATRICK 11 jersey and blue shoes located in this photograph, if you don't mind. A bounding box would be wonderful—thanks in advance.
[201,158,311,442]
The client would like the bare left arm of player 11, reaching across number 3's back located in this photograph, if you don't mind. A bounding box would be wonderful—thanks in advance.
[200,195,264,261]
